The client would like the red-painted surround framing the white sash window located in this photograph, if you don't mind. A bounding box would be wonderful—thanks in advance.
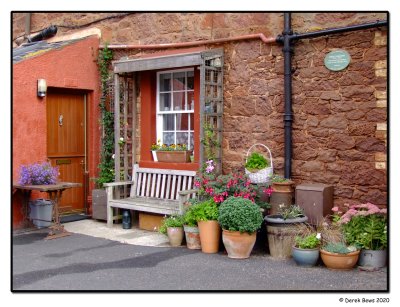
[139,67,200,171]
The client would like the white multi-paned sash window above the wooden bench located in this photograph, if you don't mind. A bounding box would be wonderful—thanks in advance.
[156,68,195,149]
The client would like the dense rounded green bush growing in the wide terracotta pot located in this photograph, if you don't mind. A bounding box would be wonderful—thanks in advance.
[218,196,263,233]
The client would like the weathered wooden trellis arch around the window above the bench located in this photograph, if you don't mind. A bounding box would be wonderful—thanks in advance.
[113,49,223,181]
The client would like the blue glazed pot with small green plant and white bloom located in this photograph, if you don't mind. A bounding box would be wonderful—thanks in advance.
[292,229,321,267]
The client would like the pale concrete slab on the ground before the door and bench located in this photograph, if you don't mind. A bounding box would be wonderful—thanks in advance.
[63,219,170,247]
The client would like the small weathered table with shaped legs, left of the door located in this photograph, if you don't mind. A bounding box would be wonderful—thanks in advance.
[13,182,82,240]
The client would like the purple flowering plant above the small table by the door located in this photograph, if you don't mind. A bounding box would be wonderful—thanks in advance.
[19,162,59,185]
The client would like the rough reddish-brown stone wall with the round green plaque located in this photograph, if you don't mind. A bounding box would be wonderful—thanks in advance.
[13,13,387,205]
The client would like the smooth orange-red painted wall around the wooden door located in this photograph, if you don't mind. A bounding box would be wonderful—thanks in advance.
[12,37,99,227]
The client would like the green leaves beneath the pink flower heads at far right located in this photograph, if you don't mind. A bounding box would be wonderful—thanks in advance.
[343,214,387,250]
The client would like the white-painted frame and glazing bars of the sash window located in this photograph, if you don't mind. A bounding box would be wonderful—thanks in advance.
[156,68,195,150]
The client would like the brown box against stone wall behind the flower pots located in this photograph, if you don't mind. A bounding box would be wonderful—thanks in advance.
[295,183,333,225]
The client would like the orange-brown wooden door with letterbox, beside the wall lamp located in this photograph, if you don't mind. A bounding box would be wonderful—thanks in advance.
[46,92,86,213]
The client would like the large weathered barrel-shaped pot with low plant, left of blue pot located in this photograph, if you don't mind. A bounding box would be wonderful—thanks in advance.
[264,205,308,259]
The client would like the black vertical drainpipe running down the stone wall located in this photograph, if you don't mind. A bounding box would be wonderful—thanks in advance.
[282,13,293,178]
